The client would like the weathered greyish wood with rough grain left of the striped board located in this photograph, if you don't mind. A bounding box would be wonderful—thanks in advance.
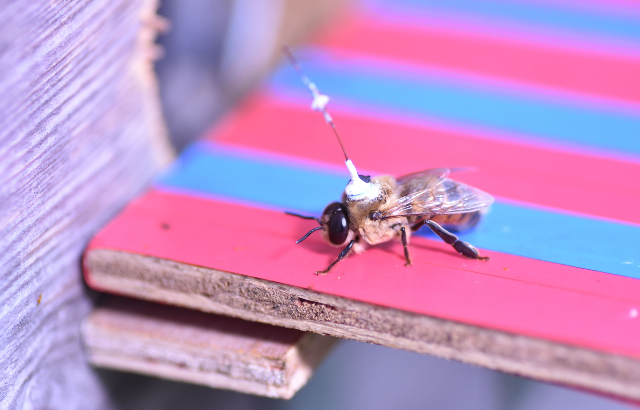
[0,0,172,409]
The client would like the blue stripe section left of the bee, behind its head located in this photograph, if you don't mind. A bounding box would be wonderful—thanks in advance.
[159,142,349,213]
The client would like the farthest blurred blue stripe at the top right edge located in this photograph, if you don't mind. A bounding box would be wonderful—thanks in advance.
[367,0,640,46]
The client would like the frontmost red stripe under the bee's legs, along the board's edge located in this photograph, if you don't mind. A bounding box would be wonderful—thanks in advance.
[86,191,640,358]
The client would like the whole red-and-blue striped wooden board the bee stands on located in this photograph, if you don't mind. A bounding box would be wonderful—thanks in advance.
[85,1,640,400]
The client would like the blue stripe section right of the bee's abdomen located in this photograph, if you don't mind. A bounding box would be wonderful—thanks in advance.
[459,200,640,279]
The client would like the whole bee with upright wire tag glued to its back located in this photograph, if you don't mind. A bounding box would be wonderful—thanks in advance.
[285,47,494,275]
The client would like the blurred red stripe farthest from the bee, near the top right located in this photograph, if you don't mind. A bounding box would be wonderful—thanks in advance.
[319,15,640,103]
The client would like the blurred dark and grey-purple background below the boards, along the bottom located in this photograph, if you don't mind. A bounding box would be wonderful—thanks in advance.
[99,340,632,410]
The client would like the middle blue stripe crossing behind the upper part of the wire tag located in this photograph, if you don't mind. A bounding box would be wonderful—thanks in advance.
[271,52,640,154]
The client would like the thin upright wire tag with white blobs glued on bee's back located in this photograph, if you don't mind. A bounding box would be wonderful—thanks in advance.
[284,46,378,200]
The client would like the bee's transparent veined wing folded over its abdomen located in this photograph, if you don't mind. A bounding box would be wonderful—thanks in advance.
[380,178,494,219]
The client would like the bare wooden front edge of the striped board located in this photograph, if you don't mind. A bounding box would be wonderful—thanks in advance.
[85,249,640,400]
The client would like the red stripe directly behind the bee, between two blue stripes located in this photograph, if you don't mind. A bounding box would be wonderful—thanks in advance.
[209,96,640,224]
